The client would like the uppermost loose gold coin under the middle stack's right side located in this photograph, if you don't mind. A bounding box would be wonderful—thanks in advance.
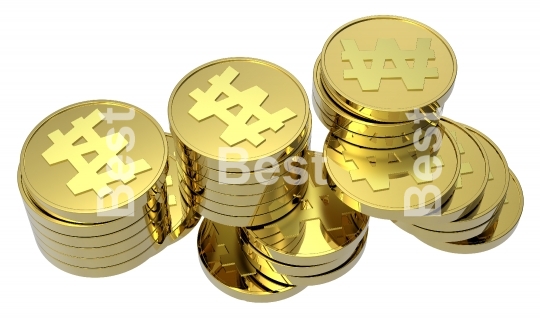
[244,151,369,266]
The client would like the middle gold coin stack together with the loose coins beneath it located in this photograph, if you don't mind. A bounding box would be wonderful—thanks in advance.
[169,58,368,301]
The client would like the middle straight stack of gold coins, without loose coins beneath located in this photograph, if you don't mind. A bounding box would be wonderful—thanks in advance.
[169,58,311,226]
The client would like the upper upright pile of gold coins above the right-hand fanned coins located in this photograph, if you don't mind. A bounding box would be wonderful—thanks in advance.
[313,16,457,148]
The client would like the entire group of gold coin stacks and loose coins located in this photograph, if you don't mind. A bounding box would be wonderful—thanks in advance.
[17,16,523,302]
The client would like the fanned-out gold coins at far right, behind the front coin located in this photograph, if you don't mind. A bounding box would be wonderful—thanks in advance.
[395,123,523,253]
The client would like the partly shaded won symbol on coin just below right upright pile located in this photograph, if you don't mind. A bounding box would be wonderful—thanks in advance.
[343,141,444,191]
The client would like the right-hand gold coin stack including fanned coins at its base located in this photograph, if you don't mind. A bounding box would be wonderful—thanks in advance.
[313,16,523,253]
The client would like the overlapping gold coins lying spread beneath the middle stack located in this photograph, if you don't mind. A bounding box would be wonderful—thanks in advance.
[198,151,369,302]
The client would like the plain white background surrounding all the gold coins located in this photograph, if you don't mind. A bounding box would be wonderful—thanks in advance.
[0,0,540,325]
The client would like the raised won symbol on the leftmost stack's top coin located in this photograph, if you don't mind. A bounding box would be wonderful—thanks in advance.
[41,109,151,198]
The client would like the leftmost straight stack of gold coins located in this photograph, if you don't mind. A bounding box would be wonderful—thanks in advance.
[17,100,198,277]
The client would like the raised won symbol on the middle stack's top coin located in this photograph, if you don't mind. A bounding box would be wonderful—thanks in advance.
[189,67,296,146]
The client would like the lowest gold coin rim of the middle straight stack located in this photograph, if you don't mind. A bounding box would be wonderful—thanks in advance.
[181,176,308,226]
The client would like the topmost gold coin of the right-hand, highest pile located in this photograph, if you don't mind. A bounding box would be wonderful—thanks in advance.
[321,16,457,122]
